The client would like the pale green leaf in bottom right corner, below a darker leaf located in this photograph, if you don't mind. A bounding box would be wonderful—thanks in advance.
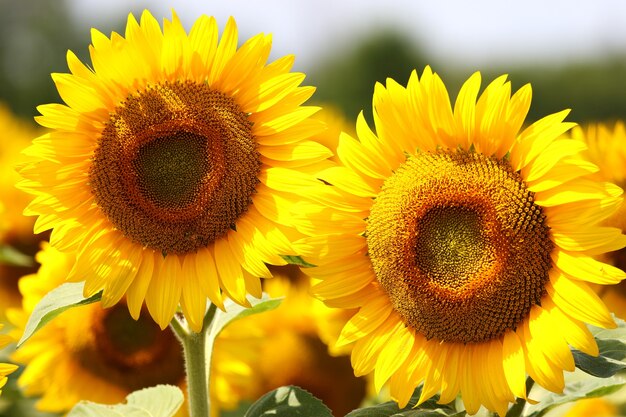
[524,374,626,417]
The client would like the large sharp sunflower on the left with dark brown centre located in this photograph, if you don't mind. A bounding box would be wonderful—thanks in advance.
[21,11,331,331]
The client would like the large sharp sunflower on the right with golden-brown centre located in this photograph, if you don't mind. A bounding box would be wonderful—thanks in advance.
[295,67,626,415]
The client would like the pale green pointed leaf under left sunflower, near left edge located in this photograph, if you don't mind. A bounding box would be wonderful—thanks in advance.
[17,282,102,347]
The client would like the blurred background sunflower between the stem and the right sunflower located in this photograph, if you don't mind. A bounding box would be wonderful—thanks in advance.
[213,265,368,416]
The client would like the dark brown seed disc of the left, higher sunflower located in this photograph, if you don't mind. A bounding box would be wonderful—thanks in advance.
[89,81,261,254]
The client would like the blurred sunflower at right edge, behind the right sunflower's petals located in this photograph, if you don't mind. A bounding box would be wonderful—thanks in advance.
[571,121,626,319]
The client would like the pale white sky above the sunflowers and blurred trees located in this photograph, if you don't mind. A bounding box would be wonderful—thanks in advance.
[64,0,626,70]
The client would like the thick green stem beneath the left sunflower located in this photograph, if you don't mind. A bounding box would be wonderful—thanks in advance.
[170,304,216,417]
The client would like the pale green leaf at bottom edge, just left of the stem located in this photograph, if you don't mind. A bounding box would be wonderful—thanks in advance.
[67,385,184,417]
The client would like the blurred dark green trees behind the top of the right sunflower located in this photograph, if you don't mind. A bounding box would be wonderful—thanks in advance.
[311,30,626,123]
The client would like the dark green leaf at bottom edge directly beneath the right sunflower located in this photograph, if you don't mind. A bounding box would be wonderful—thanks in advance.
[346,386,466,417]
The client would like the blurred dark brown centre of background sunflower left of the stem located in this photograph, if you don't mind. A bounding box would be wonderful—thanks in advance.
[79,303,184,391]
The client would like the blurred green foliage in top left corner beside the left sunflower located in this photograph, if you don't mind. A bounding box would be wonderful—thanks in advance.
[0,0,138,118]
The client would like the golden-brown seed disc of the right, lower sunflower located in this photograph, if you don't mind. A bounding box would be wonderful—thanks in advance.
[367,150,554,343]
